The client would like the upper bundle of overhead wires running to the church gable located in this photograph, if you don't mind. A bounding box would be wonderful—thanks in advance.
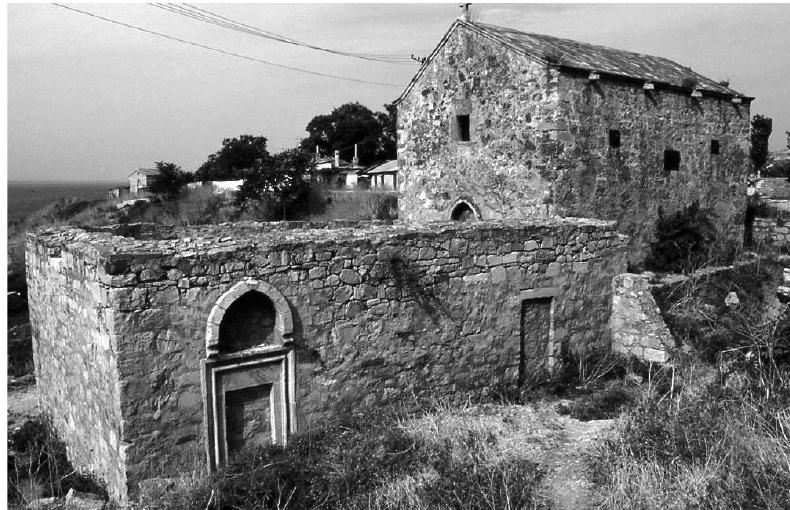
[149,3,413,65]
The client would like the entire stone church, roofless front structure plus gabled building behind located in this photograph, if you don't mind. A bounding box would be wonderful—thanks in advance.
[26,14,750,501]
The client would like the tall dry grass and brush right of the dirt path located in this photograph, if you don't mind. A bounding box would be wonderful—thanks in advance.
[593,311,790,510]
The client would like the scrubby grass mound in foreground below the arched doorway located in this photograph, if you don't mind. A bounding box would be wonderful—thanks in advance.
[149,406,543,510]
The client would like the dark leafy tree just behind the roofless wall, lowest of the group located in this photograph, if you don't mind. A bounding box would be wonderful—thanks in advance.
[236,149,310,219]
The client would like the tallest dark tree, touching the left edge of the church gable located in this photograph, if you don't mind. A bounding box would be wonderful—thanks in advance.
[301,102,396,165]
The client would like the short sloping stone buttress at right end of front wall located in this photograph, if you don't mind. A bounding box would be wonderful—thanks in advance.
[609,273,675,363]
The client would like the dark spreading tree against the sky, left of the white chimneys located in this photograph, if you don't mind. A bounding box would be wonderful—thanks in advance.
[195,135,270,181]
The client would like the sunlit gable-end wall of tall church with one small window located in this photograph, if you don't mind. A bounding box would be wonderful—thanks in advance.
[398,28,559,221]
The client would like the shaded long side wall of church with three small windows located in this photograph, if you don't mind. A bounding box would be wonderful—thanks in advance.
[552,72,750,255]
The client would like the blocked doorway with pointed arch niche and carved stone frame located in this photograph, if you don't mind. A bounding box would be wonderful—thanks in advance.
[202,279,296,469]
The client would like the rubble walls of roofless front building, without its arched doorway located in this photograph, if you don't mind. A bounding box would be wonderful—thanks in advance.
[29,220,627,494]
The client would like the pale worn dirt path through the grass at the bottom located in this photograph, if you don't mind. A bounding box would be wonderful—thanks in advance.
[540,416,617,510]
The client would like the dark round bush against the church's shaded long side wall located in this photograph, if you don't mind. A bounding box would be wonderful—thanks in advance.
[645,202,717,272]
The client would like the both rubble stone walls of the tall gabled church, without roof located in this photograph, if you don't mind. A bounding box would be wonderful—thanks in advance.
[398,26,750,256]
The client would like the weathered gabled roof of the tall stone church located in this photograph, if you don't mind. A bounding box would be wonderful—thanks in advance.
[396,19,753,103]
